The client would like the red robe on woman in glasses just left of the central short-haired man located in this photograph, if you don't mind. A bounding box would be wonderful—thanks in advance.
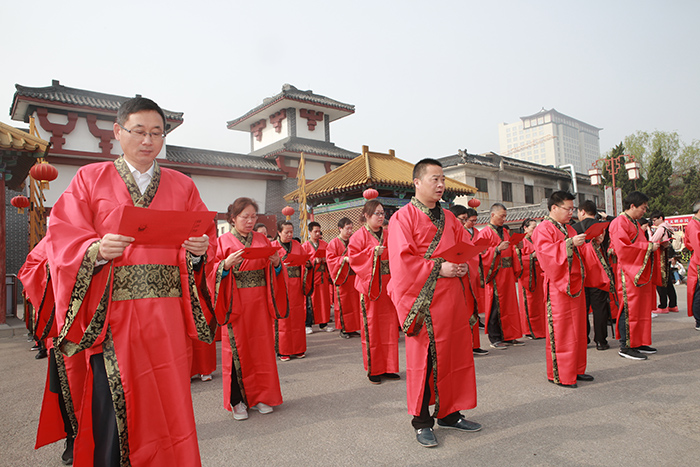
[348,226,399,376]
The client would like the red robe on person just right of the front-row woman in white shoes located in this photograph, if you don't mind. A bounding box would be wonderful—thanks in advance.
[272,240,312,355]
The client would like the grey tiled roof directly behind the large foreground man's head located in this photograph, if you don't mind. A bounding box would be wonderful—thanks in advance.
[10,80,184,122]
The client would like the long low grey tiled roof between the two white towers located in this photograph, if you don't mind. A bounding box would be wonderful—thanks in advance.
[165,145,282,173]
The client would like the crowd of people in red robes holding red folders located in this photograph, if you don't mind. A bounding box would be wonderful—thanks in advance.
[20,102,700,466]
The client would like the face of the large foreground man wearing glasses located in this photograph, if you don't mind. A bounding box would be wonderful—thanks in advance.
[114,110,164,172]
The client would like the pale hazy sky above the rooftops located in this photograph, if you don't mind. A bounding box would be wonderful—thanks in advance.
[0,0,700,162]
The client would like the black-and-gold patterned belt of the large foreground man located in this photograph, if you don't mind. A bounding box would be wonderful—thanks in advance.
[112,264,182,302]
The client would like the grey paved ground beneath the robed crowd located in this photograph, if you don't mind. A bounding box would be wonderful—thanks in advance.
[0,286,700,466]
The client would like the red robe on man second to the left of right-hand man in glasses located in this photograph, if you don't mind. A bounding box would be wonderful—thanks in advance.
[479,224,523,341]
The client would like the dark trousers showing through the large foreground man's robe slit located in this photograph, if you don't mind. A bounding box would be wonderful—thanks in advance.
[90,353,120,467]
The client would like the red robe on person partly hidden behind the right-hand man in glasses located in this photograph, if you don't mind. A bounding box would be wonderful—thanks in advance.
[515,238,547,338]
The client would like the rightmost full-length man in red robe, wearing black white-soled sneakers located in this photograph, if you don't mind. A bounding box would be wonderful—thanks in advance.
[610,191,659,360]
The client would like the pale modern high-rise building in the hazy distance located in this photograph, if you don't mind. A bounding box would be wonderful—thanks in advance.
[498,108,602,173]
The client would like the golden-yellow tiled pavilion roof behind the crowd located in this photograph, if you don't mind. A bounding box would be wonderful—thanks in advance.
[284,151,476,201]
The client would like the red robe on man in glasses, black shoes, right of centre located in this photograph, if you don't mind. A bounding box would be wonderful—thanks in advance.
[532,217,588,384]
